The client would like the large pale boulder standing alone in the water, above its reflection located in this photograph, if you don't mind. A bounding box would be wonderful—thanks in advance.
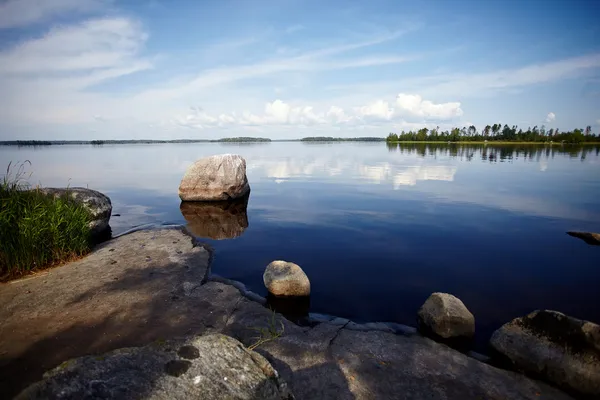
[179,154,250,201]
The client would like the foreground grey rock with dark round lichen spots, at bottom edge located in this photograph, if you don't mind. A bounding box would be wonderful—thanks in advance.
[16,334,293,400]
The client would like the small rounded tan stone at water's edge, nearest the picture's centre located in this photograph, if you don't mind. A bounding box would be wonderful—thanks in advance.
[263,260,310,297]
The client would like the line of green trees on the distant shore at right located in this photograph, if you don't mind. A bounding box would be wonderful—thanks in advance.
[386,124,600,143]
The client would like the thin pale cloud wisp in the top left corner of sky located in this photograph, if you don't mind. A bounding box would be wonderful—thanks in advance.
[0,0,111,29]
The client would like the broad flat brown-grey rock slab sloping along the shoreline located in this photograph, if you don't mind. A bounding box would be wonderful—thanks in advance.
[0,230,571,400]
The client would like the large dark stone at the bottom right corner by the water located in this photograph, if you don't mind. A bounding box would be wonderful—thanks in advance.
[490,310,600,396]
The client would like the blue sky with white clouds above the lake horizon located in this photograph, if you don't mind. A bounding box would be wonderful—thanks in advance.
[0,0,600,140]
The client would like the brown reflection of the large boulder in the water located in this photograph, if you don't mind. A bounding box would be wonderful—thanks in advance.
[179,196,248,240]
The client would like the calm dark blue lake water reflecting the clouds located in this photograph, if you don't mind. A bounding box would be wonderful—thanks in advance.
[0,143,600,343]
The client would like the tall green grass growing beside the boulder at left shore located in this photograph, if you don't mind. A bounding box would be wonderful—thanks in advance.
[0,162,92,281]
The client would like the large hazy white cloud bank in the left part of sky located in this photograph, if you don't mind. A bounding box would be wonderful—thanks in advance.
[0,17,153,124]
